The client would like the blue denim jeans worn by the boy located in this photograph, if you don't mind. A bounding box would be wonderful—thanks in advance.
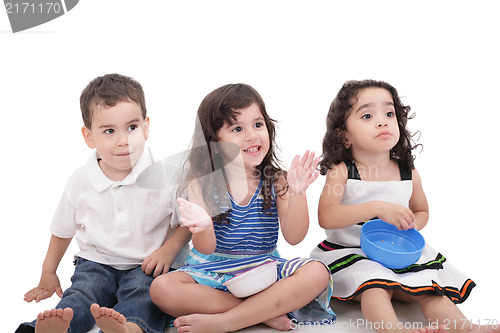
[21,258,173,333]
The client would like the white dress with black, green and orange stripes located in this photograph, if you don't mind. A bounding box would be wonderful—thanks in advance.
[311,163,475,304]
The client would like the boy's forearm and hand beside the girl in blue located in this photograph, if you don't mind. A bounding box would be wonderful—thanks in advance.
[141,226,191,277]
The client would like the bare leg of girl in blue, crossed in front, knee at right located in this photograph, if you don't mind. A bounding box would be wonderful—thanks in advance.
[174,262,330,332]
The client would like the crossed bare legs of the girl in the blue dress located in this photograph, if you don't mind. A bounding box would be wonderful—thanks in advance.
[151,262,330,332]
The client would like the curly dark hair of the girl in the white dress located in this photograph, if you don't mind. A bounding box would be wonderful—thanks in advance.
[319,80,421,175]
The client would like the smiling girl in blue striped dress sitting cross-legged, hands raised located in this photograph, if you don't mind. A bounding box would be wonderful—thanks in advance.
[151,84,335,332]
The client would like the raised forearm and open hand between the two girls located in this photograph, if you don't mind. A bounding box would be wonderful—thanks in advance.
[276,151,319,245]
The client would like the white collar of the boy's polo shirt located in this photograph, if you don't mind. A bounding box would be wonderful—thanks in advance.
[87,149,151,192]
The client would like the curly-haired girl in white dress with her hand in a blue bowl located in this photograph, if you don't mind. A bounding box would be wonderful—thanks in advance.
[311,80,495,332]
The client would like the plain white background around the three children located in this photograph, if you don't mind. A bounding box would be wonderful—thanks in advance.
[0,0,500,332]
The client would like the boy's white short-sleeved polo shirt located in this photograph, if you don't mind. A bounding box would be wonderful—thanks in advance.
[50,151,189,270]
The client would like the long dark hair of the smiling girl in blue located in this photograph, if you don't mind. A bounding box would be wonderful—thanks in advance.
[179,83,287,222]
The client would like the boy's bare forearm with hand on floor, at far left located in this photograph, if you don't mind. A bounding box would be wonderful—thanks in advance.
[24,235,72,303]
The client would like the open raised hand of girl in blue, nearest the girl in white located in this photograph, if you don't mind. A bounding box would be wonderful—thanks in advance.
[287,150,319,195]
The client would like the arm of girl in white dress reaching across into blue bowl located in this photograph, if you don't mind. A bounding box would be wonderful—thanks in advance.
[318,163,415,230]
